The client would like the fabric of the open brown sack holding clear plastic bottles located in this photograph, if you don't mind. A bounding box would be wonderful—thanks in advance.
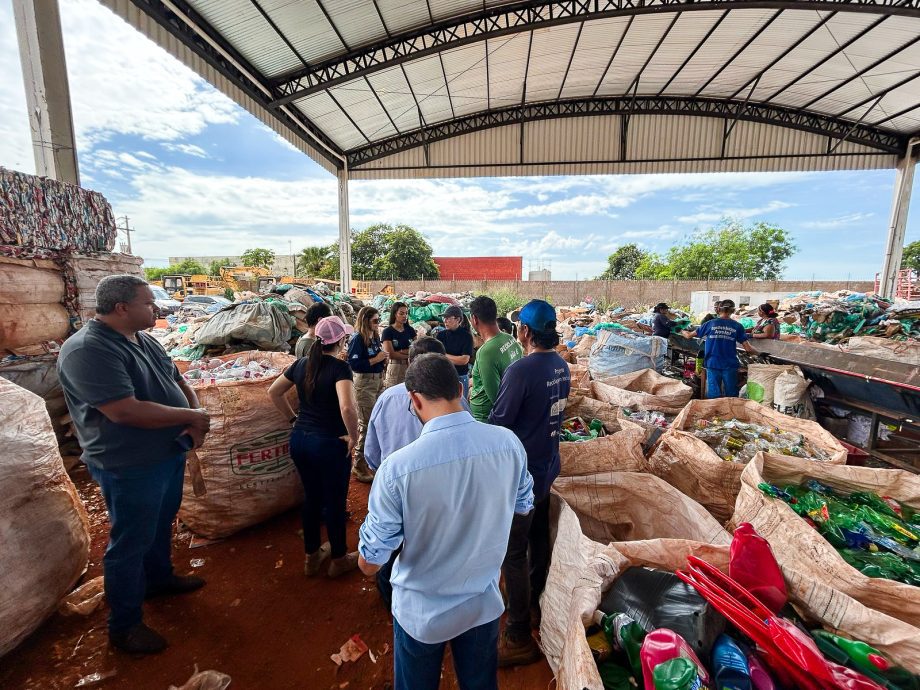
[648,398,847,522]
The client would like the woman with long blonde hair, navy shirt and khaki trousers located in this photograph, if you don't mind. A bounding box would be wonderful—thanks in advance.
[348,307,390,484]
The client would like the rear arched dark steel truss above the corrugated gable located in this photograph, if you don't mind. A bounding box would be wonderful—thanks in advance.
[347,95,907,169]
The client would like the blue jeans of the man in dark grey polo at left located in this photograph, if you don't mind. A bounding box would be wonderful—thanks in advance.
[89,455,185,633]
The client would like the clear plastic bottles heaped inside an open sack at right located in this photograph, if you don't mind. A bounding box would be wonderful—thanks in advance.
[691,418,831,464]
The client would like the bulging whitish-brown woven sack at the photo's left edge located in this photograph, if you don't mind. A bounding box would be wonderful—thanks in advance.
[0,378,89,656]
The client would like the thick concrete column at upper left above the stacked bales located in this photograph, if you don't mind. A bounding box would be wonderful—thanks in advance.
[13,0,80,185]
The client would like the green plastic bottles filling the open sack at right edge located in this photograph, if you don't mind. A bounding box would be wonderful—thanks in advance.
[759,479,920,586]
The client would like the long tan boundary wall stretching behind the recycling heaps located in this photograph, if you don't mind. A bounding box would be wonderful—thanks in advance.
[362,280,875,307]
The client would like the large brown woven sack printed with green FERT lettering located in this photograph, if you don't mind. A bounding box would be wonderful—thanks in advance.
[179,351,303,539]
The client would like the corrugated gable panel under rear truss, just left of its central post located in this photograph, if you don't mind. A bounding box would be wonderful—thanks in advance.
[524,115,620,163]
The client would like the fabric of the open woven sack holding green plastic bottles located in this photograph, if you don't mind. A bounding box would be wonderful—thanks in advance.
[731,453,920,628]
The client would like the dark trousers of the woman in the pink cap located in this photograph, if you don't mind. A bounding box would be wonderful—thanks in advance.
[291,429,351,558]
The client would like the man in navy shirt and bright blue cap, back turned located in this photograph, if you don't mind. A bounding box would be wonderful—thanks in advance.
[489,300,571,666]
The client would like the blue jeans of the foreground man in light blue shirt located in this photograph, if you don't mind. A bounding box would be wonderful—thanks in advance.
[393,618,498,690]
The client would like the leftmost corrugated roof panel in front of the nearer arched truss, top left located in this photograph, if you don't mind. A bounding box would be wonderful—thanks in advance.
[191,0,303,74]
